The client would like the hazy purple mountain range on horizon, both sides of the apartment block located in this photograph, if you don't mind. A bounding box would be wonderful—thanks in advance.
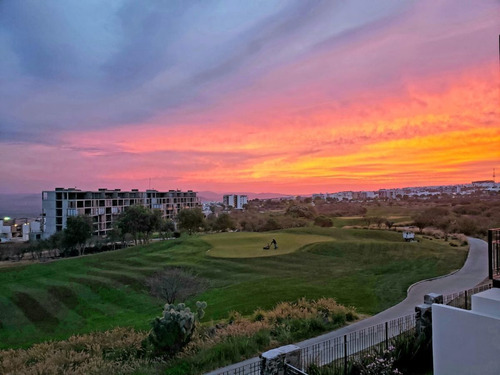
[0,191,287,218]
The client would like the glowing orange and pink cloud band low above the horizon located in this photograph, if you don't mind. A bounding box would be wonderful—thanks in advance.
[59,61,500,193]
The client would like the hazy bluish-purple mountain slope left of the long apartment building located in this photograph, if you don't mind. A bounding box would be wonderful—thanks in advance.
[0,193,42,218]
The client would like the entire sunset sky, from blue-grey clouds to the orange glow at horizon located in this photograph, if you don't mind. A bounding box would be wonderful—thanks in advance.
[0,0,500,194]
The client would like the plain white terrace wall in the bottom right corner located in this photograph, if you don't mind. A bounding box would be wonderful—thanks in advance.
[432,289,500,375]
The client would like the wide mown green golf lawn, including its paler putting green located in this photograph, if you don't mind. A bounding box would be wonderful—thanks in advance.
[0,228,467,348]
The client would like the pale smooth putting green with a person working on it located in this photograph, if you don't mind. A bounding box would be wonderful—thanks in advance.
[203,232,333,258]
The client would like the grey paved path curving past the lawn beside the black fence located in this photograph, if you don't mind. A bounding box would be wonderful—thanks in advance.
[207,238,488,375]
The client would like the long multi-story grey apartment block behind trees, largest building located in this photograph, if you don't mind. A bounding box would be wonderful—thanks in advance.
[42,188,198,238]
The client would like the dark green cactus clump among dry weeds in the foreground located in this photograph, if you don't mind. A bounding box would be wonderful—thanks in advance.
[148,301,207,356]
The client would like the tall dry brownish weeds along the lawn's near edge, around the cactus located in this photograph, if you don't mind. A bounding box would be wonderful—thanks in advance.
[0,298,356,375]
